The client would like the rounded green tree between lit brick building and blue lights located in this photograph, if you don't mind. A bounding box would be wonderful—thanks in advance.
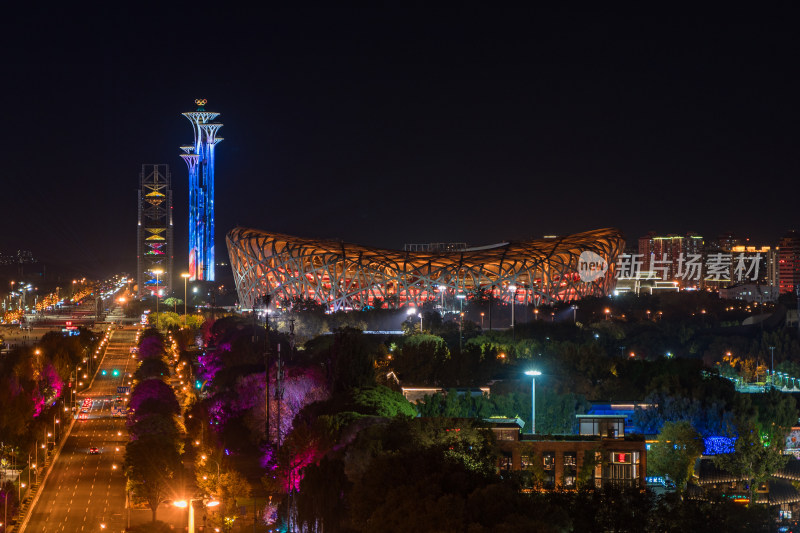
[647,420,703,490]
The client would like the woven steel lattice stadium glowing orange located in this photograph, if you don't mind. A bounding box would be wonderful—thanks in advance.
[226,227,625,311]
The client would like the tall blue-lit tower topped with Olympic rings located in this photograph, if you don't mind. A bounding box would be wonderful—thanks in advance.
[181,100,222,281]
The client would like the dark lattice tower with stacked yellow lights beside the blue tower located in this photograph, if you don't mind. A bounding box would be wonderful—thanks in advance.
[137,165,174,298]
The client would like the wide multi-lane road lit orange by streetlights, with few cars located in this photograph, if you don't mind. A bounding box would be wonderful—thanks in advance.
[22,327,137,533]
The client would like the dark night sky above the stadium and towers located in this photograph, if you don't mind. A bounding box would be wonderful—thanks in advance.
[0,6,800,272]
